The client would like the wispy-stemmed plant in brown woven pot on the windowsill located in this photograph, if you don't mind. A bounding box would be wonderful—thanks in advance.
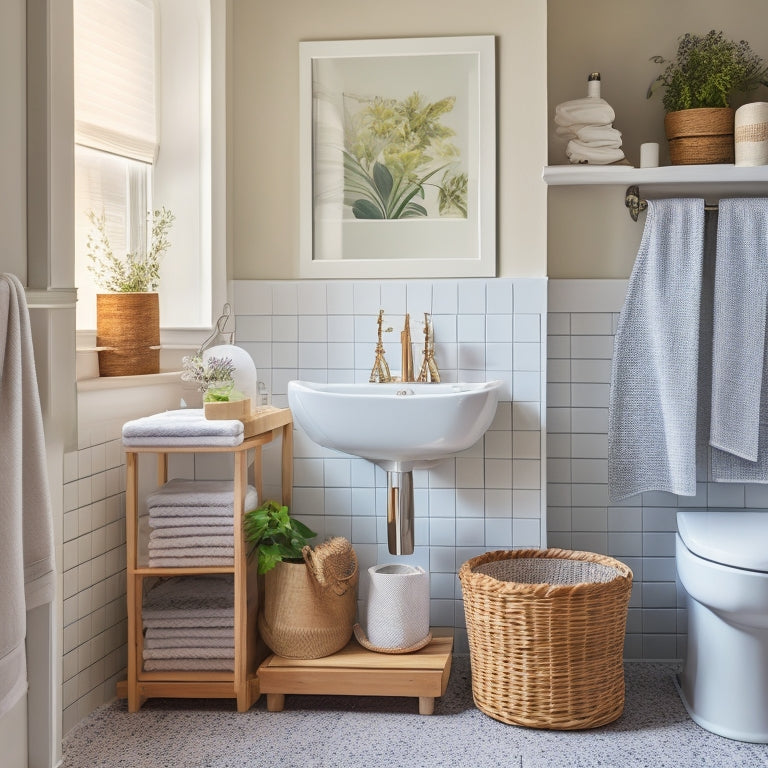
[86,208,175,376]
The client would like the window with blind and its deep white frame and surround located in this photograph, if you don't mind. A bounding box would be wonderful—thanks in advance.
[74,0,222,342]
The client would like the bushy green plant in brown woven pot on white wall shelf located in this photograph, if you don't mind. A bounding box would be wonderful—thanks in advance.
[646,29,768,165]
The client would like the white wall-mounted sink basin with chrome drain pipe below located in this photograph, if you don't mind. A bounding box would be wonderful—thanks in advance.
[288,381,503,555]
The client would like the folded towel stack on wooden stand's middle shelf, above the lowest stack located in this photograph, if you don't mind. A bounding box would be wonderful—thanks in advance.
[147,479,258,568]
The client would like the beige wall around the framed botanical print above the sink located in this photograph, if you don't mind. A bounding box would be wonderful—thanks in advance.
[230,0,547,280]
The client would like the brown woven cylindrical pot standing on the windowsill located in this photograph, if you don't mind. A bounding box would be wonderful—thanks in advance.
[96,293,160,376]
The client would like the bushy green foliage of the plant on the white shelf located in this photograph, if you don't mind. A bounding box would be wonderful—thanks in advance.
[646,29,768,112]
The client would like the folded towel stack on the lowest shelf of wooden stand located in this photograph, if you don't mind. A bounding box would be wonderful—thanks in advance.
[142,576,235,672]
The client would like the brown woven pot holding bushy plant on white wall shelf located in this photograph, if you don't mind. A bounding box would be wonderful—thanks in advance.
[664,107,734,165]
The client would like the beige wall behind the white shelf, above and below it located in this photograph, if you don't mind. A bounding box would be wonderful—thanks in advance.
[547,0,768,278]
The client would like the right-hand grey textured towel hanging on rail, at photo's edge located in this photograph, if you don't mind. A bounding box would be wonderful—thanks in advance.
[709,198,768,483]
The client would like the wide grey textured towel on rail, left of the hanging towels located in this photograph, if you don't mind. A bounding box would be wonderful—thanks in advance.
[608,199,704,501]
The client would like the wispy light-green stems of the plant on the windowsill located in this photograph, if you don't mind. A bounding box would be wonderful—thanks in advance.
[86,208,176,293]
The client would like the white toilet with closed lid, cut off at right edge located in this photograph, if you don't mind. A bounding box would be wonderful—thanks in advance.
[675,509,768,744]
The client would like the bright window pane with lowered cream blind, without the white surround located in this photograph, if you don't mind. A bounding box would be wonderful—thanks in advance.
[73,0,157,328]
